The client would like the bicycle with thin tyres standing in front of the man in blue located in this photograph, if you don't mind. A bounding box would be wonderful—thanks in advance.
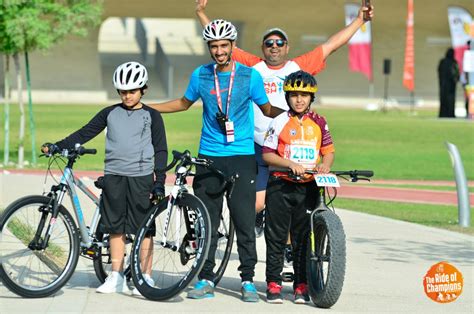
[131,151,238,301]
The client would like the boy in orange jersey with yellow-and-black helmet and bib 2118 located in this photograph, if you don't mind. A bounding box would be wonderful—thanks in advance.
[262,71,335,304]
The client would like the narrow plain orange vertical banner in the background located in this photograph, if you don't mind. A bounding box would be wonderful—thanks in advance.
[403,0,415,92]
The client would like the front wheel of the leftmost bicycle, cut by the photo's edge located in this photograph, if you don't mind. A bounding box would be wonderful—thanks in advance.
[0,196,79,298]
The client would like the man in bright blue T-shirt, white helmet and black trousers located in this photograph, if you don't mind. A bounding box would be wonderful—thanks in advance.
[150,20,283,302]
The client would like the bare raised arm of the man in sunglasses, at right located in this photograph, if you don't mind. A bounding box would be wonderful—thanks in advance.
[321,5,374,59]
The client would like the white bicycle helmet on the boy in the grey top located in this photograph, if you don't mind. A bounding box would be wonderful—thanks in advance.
[112,61,148,90]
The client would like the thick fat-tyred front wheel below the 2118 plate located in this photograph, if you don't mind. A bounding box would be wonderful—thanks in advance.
[306,210,346,308]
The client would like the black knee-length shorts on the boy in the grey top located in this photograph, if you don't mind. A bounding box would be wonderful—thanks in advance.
[100,174,154,234]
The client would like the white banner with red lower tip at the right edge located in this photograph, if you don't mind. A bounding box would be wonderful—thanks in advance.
[448,6,474,73]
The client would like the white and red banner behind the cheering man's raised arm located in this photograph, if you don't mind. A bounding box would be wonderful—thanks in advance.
[344,3,373,82]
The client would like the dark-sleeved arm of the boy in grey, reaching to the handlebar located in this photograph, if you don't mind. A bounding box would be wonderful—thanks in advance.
[55,106,110,149]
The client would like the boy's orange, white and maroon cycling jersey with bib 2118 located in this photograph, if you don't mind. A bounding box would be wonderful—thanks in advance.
[262,111,335,181]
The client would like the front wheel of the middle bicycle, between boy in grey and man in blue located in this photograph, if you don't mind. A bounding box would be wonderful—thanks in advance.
[131,193,211,301]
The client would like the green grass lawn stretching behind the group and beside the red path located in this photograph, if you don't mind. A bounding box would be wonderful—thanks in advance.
[0,105,474,233]
